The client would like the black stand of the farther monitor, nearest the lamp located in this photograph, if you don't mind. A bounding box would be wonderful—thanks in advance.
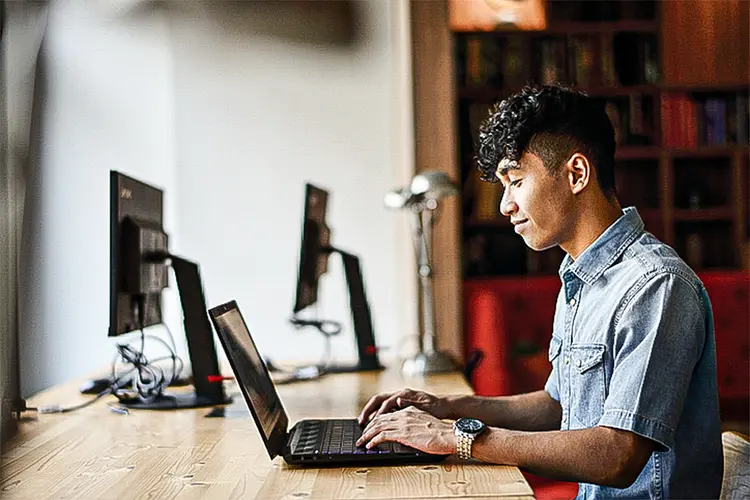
[323,247,383,373]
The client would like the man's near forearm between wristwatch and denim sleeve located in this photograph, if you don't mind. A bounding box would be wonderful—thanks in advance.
[471,427,654,488]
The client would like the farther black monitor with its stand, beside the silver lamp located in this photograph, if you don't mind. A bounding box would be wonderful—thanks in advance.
[292,183,382,372]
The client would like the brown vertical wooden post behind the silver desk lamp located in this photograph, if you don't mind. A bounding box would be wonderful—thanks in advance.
[411,0,464,368]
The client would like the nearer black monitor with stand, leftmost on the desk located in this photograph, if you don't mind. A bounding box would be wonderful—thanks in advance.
[109,171,229,409]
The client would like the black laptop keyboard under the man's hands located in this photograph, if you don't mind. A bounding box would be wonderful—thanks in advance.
[292,419,416,455]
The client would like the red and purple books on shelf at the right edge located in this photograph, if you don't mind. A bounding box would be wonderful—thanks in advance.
[661,93,750,148]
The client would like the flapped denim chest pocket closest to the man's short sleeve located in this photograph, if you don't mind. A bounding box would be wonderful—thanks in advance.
[570,344,606,429]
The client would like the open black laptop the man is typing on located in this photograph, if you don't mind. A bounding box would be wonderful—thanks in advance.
[208,301,446,465]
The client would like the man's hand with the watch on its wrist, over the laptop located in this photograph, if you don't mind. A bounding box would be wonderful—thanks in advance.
[357,406,456,455]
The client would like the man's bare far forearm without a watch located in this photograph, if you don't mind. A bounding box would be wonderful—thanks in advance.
[445,391,562,431]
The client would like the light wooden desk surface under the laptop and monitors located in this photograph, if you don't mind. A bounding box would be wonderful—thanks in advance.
[0,369,533,500]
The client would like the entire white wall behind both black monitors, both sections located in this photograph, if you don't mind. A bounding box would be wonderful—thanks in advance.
[21,0,416,395]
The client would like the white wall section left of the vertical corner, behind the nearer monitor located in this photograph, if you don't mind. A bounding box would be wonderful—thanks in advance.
[19,0,179,395]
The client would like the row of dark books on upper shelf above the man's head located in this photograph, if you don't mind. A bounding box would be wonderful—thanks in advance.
[458,33,659,88]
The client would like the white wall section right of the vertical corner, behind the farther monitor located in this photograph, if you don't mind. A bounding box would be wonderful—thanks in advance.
[171,1,420,368]
